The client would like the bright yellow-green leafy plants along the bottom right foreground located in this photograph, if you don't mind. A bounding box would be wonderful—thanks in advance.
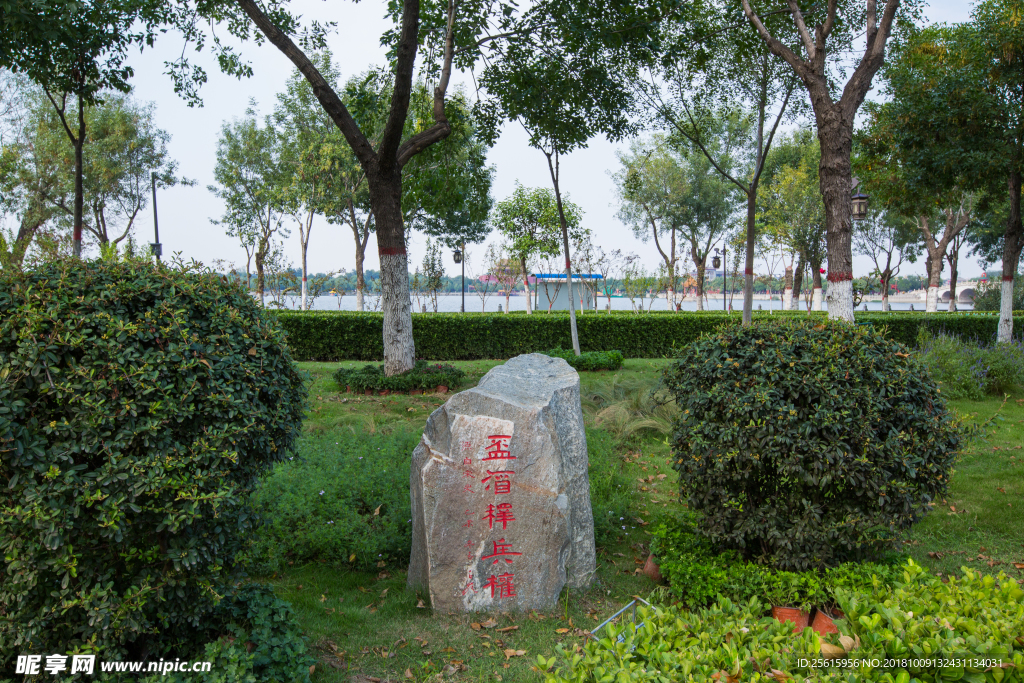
[537,561,1024,683]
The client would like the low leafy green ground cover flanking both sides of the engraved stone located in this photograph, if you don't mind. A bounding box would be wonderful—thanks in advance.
[248,430,638,575]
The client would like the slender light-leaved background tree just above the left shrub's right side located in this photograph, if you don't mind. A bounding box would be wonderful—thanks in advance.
[208,102,288,303]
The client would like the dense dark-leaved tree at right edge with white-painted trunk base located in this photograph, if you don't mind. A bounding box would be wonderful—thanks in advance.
[878,7,1024,341]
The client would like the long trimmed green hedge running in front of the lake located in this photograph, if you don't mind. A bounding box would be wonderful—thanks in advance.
[273,310,1024,360]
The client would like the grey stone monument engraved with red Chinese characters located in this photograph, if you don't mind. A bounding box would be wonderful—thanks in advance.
[409,353,596,611]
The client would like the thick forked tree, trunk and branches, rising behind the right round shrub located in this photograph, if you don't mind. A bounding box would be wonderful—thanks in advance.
[740,0,913,322]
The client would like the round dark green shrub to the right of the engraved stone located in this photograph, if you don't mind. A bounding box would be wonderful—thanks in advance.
[665,319,965,570]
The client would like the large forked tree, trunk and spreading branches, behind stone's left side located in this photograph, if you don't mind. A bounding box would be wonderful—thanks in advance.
[187,0,514,376]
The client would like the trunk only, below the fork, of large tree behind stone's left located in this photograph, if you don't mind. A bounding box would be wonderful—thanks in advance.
[368,164,416,377]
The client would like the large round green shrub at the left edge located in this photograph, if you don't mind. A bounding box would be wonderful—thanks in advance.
[0,260,305,667]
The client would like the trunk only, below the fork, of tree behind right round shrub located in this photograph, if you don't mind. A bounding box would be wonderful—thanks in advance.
[811,111,853,323]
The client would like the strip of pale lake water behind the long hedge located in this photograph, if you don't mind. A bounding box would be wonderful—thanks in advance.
[266,292,974,313]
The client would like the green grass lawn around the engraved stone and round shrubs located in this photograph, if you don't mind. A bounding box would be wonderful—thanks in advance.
[268,359,1024,682]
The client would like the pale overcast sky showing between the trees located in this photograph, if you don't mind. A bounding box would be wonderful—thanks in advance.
[125,0,981,280]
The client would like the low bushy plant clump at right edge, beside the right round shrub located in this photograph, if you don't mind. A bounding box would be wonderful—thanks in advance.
[918,330,1024,400]
